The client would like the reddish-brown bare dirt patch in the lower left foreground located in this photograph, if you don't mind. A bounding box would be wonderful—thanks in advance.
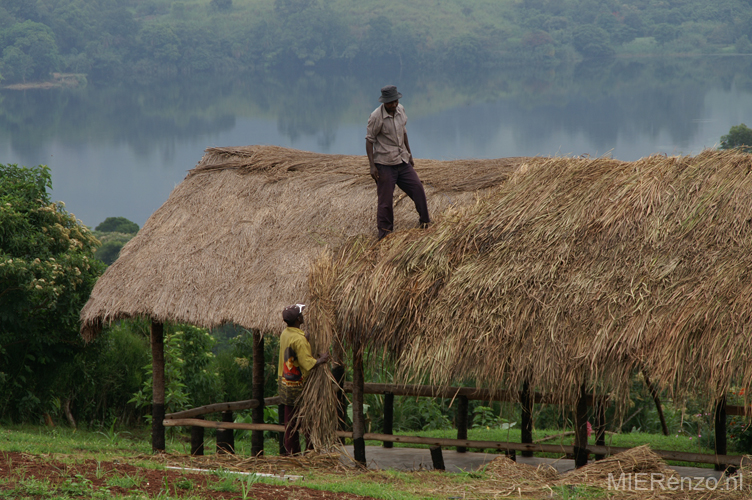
[0,452,370,500]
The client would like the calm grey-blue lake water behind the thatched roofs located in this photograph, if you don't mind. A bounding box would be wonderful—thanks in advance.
[0,58,752,227]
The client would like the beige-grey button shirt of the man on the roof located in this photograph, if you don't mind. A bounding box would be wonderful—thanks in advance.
[366,104,410,165]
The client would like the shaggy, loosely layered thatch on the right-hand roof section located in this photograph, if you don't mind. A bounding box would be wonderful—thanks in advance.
[313,150,752,402]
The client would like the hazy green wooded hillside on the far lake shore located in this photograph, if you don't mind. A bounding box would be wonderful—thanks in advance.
[0,0,752,84]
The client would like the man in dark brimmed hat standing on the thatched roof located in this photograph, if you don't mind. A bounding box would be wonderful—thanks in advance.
[366,85,431,239]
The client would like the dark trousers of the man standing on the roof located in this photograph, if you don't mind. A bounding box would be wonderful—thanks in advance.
[376,162,431,239]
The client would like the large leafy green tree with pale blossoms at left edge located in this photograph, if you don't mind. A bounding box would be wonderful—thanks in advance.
[0,165,104,419]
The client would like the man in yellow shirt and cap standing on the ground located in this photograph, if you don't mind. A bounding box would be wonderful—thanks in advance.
[277,304,329,455]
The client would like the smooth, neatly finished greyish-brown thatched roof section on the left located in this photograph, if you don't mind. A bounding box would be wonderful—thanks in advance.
[81,146,521,339]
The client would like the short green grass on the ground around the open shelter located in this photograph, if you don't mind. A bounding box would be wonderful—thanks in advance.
[0,425,732,500]
